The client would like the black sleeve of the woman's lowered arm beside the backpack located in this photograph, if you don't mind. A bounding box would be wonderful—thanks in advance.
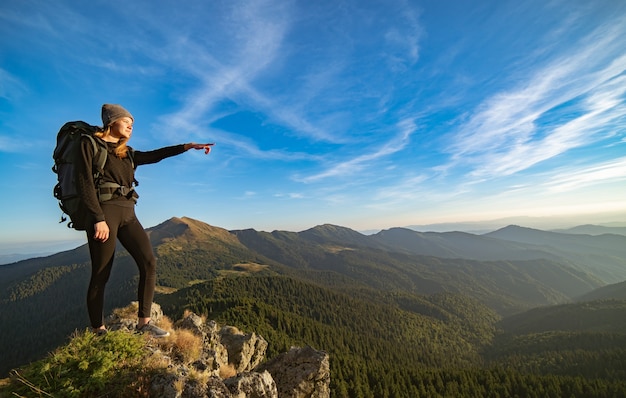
[76,138,104,224]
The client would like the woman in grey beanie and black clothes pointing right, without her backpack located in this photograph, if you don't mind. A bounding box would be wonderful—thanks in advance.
[77,104,213,337]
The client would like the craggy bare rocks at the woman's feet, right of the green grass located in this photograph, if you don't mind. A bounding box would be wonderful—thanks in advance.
[106,303,330,398]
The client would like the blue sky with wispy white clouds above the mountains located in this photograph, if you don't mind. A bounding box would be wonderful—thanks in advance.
[0,0,626,253]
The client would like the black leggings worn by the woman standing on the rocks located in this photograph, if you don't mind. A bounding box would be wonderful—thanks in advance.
[87,203,156,328]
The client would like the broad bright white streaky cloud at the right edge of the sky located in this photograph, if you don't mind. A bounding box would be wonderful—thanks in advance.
[449,16,626,178]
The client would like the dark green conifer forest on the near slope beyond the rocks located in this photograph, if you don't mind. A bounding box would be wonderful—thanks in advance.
[159,277,626,397]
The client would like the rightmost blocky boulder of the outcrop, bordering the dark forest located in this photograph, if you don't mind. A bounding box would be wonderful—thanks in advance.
[256,347,330,398]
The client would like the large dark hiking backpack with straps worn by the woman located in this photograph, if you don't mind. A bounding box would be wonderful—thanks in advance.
[52,121,136,231]
